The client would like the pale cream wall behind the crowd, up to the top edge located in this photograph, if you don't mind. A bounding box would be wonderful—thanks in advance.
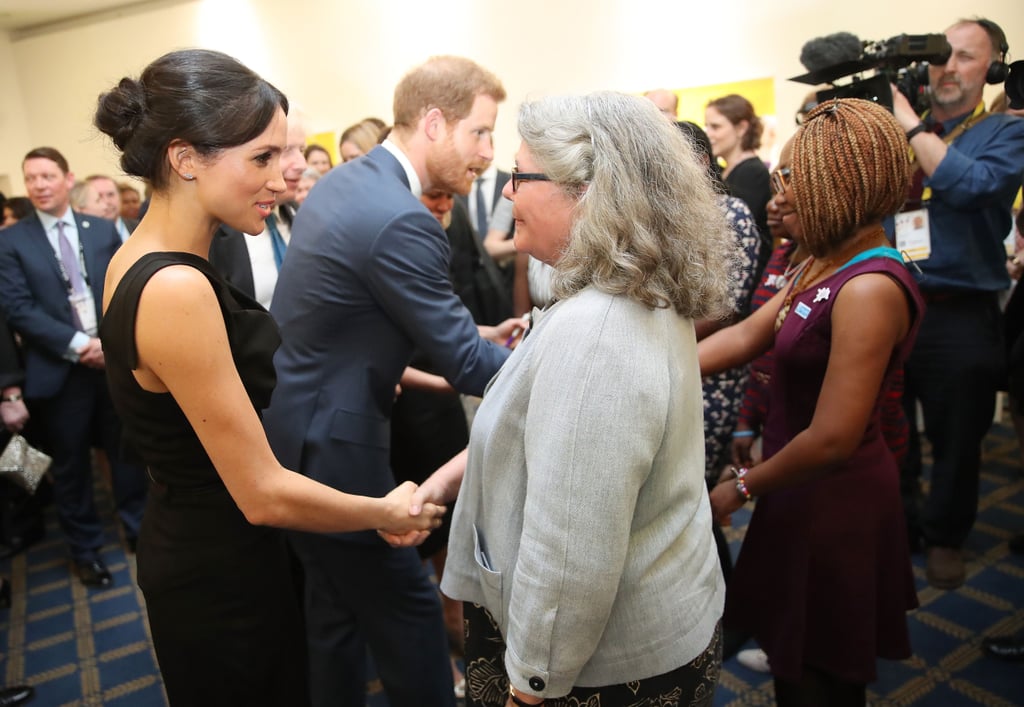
[0,0,1024,194]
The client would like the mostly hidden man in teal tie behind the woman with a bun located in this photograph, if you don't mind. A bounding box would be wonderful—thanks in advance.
[210,112,306,309]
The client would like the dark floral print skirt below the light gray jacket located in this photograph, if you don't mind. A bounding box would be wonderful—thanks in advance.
[464,602,722,707]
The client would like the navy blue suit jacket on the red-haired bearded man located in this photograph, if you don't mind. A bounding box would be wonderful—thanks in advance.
[264,148,509,538]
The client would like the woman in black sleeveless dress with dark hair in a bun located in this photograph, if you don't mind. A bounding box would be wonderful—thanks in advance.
[95,50,443,707]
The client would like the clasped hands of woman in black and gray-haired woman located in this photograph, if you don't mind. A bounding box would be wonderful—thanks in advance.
[377,450,467,547]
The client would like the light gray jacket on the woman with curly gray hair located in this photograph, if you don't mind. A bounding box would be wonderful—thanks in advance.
[441,288,724,697]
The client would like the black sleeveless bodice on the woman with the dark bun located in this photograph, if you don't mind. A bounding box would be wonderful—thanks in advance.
[99,253,281,487]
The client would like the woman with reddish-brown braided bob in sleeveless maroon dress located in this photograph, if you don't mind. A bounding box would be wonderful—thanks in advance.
[698,99,924,706]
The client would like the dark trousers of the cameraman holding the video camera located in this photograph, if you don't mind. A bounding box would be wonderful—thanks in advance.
[900,293,1006,548]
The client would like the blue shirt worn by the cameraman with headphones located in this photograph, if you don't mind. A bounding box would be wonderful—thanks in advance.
[915,114,1024,292]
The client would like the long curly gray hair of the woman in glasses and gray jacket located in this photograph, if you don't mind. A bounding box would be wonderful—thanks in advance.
[519,92,735,319]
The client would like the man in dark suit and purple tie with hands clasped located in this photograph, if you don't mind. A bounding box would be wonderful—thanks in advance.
[0,148,145,586]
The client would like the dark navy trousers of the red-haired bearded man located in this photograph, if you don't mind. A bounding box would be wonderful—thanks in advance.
[291,533,455,707]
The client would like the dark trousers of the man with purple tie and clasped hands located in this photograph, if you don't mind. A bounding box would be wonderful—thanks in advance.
[32,366,146,562]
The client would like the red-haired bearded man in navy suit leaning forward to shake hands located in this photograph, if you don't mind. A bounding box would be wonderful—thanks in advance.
[264,56,516,707]
